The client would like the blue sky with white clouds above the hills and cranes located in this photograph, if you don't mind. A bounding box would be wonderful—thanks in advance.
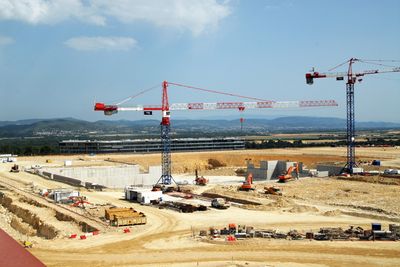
[0,0,400,122]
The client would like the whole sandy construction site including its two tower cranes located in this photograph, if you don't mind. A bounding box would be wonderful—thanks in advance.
[0,63,400,266]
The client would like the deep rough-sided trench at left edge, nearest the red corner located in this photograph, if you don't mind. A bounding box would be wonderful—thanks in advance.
[0,192,59,239]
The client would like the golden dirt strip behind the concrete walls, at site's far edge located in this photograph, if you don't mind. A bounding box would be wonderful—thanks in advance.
[15,147,400,175]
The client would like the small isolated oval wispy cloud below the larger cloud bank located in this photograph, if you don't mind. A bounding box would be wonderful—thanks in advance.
[65,36,137,51]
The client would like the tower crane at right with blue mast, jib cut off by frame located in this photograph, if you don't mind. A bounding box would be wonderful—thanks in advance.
[306,58,400,174]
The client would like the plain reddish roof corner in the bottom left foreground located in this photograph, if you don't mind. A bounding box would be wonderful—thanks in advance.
[0,229,45,267]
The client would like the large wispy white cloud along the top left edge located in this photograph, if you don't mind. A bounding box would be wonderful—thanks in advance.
[0,0,231,35]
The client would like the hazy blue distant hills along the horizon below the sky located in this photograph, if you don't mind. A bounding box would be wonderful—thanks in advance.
[0,116,400,137]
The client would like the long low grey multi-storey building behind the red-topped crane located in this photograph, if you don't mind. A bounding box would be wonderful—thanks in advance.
[59,137,245,154]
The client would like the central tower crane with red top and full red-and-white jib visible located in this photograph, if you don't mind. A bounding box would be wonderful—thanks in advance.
[94,81,338,186]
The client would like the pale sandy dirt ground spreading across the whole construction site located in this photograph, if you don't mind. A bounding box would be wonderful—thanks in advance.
[0,148,400,267]
